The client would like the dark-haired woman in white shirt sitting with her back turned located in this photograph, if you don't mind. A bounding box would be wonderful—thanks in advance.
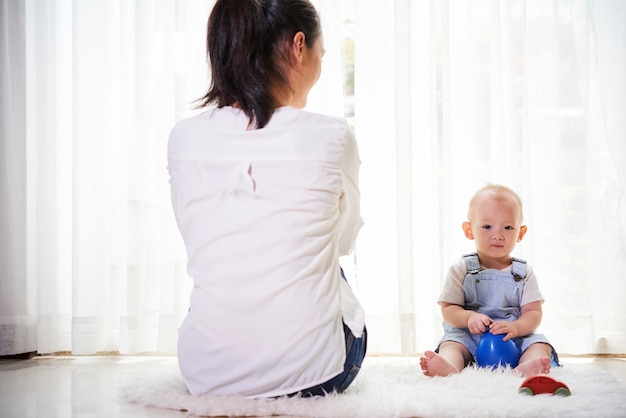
[168,0,367,397]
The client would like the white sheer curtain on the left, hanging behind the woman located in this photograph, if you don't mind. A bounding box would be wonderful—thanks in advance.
[0,0,343,355]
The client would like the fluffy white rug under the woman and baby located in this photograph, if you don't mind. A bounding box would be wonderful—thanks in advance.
[122,357,626,418]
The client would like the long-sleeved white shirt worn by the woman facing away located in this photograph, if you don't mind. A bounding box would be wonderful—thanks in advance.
[168,107,364,397]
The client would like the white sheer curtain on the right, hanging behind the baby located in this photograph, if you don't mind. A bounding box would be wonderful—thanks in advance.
[355,0,626,354]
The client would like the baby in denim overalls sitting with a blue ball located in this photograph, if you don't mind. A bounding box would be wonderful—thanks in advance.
[420,185,559,376]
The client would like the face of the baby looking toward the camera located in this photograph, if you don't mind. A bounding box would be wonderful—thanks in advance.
[469,195,525,260]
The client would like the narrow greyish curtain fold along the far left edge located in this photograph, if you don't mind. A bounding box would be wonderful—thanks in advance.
[0,2,37,354]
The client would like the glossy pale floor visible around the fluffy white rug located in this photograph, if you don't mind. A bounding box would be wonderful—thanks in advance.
[0,356,626,418]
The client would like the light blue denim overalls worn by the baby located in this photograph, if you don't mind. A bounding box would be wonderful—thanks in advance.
[435,253,559,366]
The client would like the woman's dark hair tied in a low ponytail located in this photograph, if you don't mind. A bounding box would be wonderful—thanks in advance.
[198,0,321,129]
